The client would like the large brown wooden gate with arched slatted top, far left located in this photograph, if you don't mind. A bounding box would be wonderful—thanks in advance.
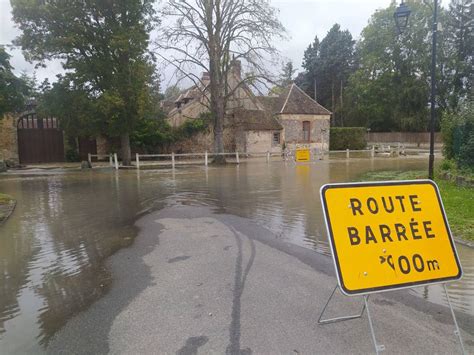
[17,112,64,164]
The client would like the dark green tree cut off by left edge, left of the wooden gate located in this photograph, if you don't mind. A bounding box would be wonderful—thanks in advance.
[0,47,29,119]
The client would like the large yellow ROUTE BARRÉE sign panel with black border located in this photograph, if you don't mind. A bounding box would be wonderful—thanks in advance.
[321,180,462,295]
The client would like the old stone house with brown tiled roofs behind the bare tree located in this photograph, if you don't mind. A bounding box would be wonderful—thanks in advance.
[162,62,331,153]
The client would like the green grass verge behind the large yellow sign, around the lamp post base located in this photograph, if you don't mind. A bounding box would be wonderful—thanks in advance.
[359,170,474,242]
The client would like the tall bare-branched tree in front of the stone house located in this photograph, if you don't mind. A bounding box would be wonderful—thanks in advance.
[158,0,284,162]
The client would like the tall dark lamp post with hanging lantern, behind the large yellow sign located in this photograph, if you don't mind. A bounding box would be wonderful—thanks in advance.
[393,0,438,180]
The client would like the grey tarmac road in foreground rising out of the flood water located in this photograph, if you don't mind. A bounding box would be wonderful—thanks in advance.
[46,206,474,354]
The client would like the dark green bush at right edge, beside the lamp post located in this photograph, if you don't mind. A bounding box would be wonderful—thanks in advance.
[441,102,474,169]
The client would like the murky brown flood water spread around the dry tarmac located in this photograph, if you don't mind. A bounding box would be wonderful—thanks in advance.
[0,158,474,353]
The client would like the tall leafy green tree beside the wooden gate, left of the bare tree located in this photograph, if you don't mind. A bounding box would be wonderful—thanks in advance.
[11,0,155,165]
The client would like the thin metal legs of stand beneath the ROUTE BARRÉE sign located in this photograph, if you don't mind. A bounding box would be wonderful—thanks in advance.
[318,283,466,355]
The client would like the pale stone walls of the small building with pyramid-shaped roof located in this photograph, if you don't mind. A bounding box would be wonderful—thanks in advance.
[278,114,330,150]
